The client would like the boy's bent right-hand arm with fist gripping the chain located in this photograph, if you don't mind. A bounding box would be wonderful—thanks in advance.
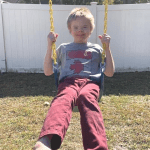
[99,34,115,77]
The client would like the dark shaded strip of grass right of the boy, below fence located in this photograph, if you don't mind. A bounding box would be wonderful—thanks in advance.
[104,72,150,95]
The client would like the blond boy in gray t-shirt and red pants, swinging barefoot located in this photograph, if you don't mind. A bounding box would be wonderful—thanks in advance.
[34,8,115,150]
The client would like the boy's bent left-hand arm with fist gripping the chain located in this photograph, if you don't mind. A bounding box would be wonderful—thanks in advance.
[44,32,58,76]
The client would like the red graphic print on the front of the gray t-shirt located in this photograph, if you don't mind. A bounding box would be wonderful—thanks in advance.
[67,50,92,74]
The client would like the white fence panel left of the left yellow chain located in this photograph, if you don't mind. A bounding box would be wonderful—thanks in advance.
[3,4,49,72]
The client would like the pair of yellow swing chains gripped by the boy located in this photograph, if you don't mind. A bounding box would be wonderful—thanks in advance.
[49,0,108,64]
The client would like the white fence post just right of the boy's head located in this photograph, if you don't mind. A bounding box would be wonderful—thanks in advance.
[91,2,97,43]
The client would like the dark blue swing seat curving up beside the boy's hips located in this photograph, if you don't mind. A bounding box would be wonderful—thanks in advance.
[53,62,105,101]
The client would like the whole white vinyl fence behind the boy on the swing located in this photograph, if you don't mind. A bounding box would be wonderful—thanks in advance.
[0,4,150,73]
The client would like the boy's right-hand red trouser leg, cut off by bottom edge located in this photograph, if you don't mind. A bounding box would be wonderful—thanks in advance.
[77,82,108,150]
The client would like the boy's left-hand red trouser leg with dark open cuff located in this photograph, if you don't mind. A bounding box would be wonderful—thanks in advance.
[39,79,77,150]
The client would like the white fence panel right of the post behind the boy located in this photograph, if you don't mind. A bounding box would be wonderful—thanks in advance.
[97,4,150,72]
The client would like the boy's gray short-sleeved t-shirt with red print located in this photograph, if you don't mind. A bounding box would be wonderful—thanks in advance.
[56,42,102,80]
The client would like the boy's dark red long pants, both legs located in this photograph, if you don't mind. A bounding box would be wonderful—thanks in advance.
[39,77,108,150]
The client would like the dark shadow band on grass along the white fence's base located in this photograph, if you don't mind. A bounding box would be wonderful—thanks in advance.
[0,72,150,98]
